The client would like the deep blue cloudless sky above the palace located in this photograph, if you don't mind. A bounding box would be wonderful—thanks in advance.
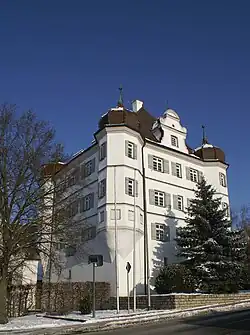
[0,0,250,208]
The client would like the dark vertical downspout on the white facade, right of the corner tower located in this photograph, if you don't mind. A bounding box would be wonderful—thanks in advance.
[141,140,151,310]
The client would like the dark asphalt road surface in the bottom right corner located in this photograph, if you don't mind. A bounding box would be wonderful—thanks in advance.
[85,310,250,335]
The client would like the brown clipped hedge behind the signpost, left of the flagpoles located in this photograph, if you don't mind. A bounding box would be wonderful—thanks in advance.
[36,282,110,313]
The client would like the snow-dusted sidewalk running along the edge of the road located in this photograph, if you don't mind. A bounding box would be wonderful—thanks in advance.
[0,301,250,335]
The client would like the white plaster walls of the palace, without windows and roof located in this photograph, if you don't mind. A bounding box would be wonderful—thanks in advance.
[45,119,228,296]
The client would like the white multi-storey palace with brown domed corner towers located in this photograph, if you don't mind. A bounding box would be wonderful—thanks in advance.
[44,98,229,296]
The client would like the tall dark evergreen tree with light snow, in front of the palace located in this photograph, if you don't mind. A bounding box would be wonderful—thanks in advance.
[176,178,246,293]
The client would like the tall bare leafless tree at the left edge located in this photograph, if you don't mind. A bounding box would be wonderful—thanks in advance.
[0,104,70,323]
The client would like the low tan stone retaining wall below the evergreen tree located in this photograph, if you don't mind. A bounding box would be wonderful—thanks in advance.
[103,293,250,310]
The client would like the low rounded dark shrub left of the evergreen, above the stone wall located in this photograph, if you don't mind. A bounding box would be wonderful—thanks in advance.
[155,264,195,294]
